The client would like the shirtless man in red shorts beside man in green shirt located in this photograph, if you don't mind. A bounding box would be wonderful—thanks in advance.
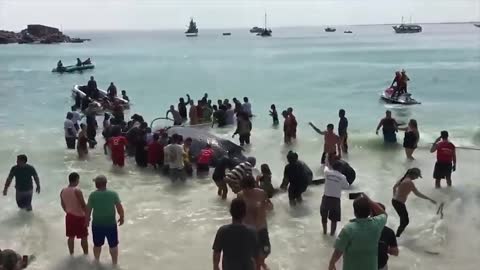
[60,172,88,255]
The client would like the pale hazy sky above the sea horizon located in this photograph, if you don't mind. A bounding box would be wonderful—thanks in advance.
[0,0,480,31]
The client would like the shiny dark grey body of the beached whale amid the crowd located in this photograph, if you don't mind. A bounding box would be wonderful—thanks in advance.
[168,127,247,166]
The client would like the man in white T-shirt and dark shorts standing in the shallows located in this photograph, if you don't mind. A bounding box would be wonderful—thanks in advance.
[320,162,350,236]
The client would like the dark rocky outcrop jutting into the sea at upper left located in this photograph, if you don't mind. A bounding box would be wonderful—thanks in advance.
[0,24,85,44]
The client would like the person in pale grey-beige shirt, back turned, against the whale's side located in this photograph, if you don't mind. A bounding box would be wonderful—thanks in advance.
[164,134,186,182]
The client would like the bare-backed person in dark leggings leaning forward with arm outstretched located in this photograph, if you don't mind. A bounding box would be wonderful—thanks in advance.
[392,168,437,237]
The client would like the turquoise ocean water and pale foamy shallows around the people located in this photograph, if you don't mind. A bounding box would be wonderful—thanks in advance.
[0,24,480,270]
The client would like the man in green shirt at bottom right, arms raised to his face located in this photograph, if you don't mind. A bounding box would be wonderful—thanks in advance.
[328,194,387,270]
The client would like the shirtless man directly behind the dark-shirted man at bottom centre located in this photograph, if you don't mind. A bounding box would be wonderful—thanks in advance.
[237,175,273,270]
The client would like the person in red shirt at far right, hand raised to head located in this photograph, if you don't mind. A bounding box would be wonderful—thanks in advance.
[430,130,457,188]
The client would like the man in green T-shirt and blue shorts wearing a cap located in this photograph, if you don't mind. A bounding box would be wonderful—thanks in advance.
[86,175,124,265]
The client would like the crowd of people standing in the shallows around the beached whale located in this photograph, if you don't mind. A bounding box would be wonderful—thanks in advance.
[0,83,462,270]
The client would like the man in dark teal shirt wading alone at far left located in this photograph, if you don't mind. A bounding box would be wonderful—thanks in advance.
[3,155,40,211]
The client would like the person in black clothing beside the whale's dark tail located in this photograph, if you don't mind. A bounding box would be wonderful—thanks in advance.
[280,151,309,206]
